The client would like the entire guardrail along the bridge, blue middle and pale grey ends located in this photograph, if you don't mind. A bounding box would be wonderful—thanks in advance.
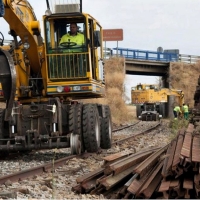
[104,48,200,63]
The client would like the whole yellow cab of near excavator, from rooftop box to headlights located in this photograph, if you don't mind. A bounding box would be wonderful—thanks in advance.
[43,2,105,99]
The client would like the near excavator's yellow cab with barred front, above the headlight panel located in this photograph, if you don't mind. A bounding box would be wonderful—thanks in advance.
[44,5,103,81]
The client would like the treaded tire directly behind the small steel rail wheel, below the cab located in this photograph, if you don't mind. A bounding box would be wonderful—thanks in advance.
[68,104,85,153]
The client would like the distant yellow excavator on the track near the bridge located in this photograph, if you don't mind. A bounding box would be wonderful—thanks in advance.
[131,83,184,121]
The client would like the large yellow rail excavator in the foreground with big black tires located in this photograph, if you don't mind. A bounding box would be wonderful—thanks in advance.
[0,0,112,154]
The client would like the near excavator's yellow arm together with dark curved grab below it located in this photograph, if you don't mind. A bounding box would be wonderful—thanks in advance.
[0,0,44,121]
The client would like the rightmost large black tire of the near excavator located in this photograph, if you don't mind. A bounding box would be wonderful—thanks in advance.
[100,105,112,149]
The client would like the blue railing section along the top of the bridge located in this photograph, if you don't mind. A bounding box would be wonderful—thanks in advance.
[110,48,179,62]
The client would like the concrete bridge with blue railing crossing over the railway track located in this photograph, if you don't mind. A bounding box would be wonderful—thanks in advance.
[104,48,200,87]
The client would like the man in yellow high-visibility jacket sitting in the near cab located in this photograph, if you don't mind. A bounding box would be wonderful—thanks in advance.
[59,23,85,52]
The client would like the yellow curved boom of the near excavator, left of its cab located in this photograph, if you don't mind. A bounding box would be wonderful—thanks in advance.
[3,0,43,73]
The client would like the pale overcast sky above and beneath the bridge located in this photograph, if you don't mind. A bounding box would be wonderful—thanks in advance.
[0,0,200,101]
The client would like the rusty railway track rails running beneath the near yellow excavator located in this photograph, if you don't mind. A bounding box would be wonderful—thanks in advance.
[0,122,162,198]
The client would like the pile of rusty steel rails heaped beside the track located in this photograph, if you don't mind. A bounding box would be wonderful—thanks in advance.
[72,124,200,199]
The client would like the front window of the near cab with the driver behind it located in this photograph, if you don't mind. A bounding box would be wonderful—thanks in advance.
[45,18,87,54]
